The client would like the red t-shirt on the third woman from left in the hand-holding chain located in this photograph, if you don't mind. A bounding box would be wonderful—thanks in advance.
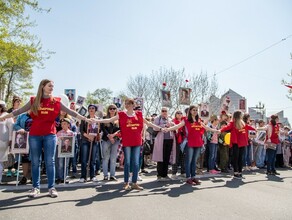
[183,118,205,147]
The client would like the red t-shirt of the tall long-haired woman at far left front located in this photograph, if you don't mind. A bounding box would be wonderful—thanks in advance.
[29,97,61,136]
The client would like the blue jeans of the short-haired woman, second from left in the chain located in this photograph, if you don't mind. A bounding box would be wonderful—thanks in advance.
[123,146,141,183]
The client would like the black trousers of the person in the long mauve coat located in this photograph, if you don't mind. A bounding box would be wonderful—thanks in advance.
[157,139,173,177]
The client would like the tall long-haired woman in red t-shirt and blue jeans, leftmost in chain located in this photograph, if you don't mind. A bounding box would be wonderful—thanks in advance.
[0,79,86,198]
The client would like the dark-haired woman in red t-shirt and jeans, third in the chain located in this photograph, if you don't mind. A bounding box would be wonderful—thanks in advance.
[165,105,218,185]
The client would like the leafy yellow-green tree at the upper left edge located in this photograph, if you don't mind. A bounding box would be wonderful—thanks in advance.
[0,0,51,102]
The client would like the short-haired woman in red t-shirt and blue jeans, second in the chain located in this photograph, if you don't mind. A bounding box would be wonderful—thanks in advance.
[92,99,162,190]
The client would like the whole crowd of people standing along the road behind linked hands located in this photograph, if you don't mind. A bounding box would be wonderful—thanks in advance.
[0,80,292,198]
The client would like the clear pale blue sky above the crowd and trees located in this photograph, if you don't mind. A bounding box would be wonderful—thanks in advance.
[30,0,292,122]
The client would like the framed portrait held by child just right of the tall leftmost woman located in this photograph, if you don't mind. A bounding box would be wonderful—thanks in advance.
[58,136,75,157]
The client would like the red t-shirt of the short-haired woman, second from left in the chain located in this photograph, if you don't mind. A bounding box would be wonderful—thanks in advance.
[118,111,144,147]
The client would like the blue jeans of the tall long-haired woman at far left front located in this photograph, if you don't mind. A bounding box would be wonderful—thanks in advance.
[29,134,57,189]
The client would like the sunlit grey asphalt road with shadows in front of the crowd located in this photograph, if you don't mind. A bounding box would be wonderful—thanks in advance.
[0,170,292,220]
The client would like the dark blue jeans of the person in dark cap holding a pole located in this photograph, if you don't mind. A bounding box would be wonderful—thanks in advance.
[81,140,98,179]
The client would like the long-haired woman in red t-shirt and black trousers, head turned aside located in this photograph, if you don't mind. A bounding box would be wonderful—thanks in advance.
[220,111,255,179]
